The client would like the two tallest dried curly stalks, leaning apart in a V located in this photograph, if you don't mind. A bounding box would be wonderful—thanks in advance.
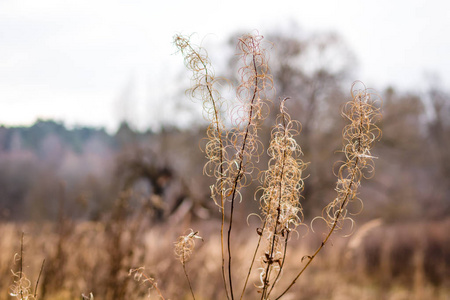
[174,31,272,299]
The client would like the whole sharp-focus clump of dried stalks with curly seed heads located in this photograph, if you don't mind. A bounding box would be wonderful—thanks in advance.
[174,34,381,299]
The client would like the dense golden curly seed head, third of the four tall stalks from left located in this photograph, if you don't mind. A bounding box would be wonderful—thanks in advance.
[259,99,306,286]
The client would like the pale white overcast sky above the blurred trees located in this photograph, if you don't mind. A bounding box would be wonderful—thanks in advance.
[0,0,450,130]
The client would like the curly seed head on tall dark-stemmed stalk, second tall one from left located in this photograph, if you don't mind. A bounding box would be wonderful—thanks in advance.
[225,34,273,191]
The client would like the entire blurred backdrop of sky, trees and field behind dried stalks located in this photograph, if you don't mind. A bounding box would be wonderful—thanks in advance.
[0,0,450,299]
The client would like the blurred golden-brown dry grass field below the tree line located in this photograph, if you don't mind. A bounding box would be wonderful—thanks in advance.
[0,220,450,300]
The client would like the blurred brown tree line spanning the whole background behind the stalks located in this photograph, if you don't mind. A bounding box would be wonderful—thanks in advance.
[0,28,450,221]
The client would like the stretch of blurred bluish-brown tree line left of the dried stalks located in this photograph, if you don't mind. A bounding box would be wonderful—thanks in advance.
[0,120,209,221]
